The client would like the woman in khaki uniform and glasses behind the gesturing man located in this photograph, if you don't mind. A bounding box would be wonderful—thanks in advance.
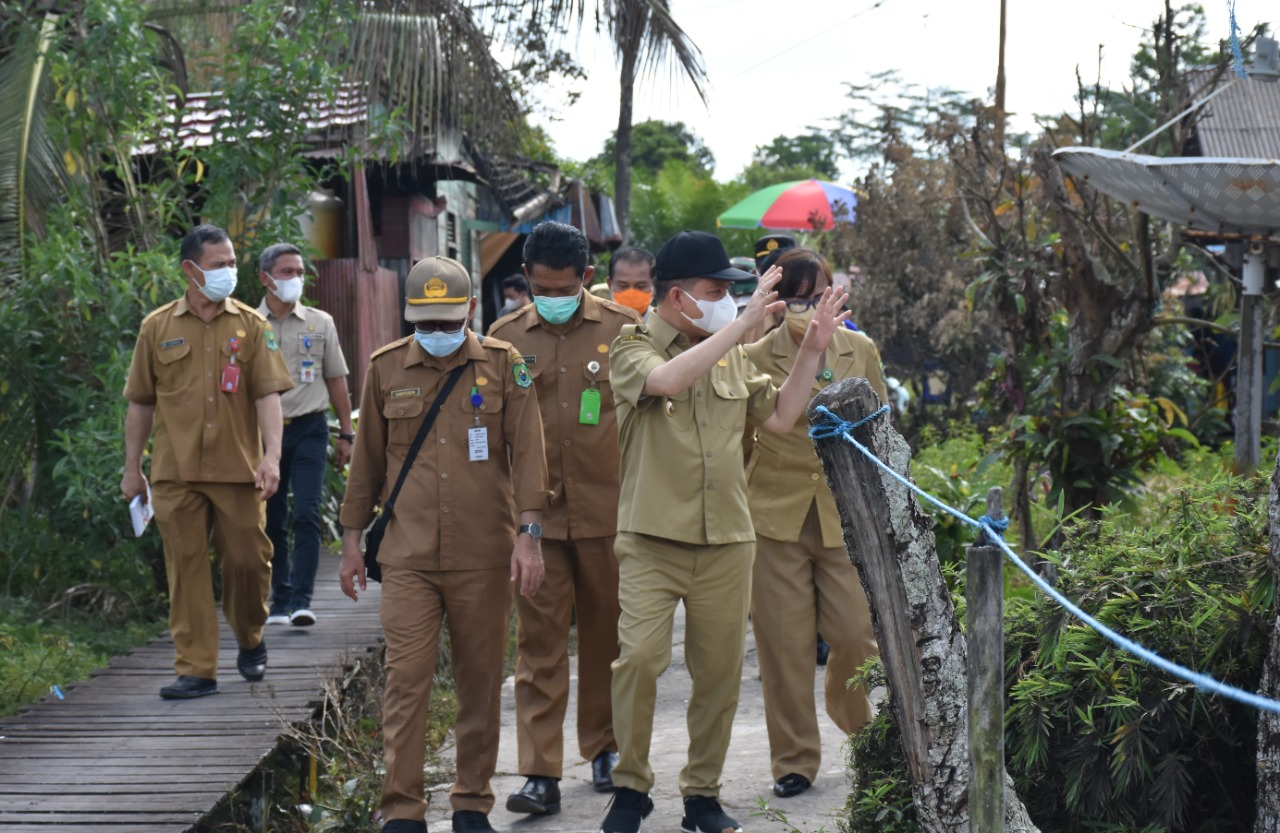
[746,248,888,798]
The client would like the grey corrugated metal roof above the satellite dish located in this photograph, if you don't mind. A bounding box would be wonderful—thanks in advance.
[1189,69,1280,159]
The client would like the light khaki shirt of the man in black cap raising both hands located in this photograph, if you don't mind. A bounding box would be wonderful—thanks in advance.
[609,315,778,544]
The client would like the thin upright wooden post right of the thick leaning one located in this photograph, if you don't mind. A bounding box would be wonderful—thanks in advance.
[965,486,1005,833]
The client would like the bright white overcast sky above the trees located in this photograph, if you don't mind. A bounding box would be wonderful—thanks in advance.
[534,0,1259,180]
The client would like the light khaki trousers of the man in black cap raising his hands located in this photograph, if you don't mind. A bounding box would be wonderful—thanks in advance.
[613,532,755,797]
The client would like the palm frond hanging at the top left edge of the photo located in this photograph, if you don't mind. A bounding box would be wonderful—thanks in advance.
[0,14,65,284]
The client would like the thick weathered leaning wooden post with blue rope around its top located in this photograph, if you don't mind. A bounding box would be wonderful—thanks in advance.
[809,377,1037,833]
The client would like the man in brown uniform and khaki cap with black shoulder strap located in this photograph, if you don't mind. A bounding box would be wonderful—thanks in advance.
[338,257,547,833]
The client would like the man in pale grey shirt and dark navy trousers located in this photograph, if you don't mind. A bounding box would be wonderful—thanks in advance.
[257,243,356,627]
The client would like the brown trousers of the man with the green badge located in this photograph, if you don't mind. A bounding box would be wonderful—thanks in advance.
[516,537,618,778]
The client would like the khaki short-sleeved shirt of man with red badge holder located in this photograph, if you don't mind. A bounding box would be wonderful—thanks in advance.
[124,296,292,482]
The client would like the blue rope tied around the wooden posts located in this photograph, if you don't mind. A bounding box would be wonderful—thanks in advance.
[809,406,1280,714]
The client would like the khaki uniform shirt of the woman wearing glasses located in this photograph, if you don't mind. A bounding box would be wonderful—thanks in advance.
[746,324,888,546]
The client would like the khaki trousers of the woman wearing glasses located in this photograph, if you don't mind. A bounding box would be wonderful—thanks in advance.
[751,505,879,781]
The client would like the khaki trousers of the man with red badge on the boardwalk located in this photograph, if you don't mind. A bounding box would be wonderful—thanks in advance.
[151,480,271,679]
